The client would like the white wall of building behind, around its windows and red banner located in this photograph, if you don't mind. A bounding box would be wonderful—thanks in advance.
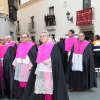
[18,0,100,40]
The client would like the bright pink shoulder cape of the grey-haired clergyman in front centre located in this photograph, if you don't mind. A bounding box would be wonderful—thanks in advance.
[36,42,54,62]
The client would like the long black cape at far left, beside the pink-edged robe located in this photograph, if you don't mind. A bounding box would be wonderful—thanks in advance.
[0,46,14,99]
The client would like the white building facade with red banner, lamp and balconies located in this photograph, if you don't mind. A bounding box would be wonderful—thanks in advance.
[16,0,100,41]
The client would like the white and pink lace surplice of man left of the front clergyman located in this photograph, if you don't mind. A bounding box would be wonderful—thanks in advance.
[13,56,33,82]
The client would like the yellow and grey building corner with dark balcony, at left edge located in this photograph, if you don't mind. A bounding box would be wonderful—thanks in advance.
[0,0,17,40]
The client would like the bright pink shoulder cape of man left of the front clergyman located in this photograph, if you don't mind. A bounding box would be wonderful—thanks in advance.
[16,42,34,59]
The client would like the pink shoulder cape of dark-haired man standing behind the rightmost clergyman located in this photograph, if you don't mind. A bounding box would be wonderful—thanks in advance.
[65,37,77,51]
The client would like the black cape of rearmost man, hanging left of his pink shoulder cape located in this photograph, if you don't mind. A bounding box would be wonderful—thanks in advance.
[57,39,68,73]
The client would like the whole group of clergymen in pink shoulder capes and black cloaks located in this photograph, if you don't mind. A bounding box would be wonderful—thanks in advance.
[0,30,100,100]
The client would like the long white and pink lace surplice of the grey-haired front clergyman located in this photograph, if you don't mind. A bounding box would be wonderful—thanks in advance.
[35,58,53,94]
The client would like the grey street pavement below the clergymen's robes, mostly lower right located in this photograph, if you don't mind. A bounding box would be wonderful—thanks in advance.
[0,78,100,100]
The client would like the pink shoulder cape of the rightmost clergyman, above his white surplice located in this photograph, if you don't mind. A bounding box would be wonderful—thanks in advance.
[74,40,90,54]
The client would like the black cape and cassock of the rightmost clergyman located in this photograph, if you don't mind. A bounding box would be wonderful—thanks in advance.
[65,44,97,91]
